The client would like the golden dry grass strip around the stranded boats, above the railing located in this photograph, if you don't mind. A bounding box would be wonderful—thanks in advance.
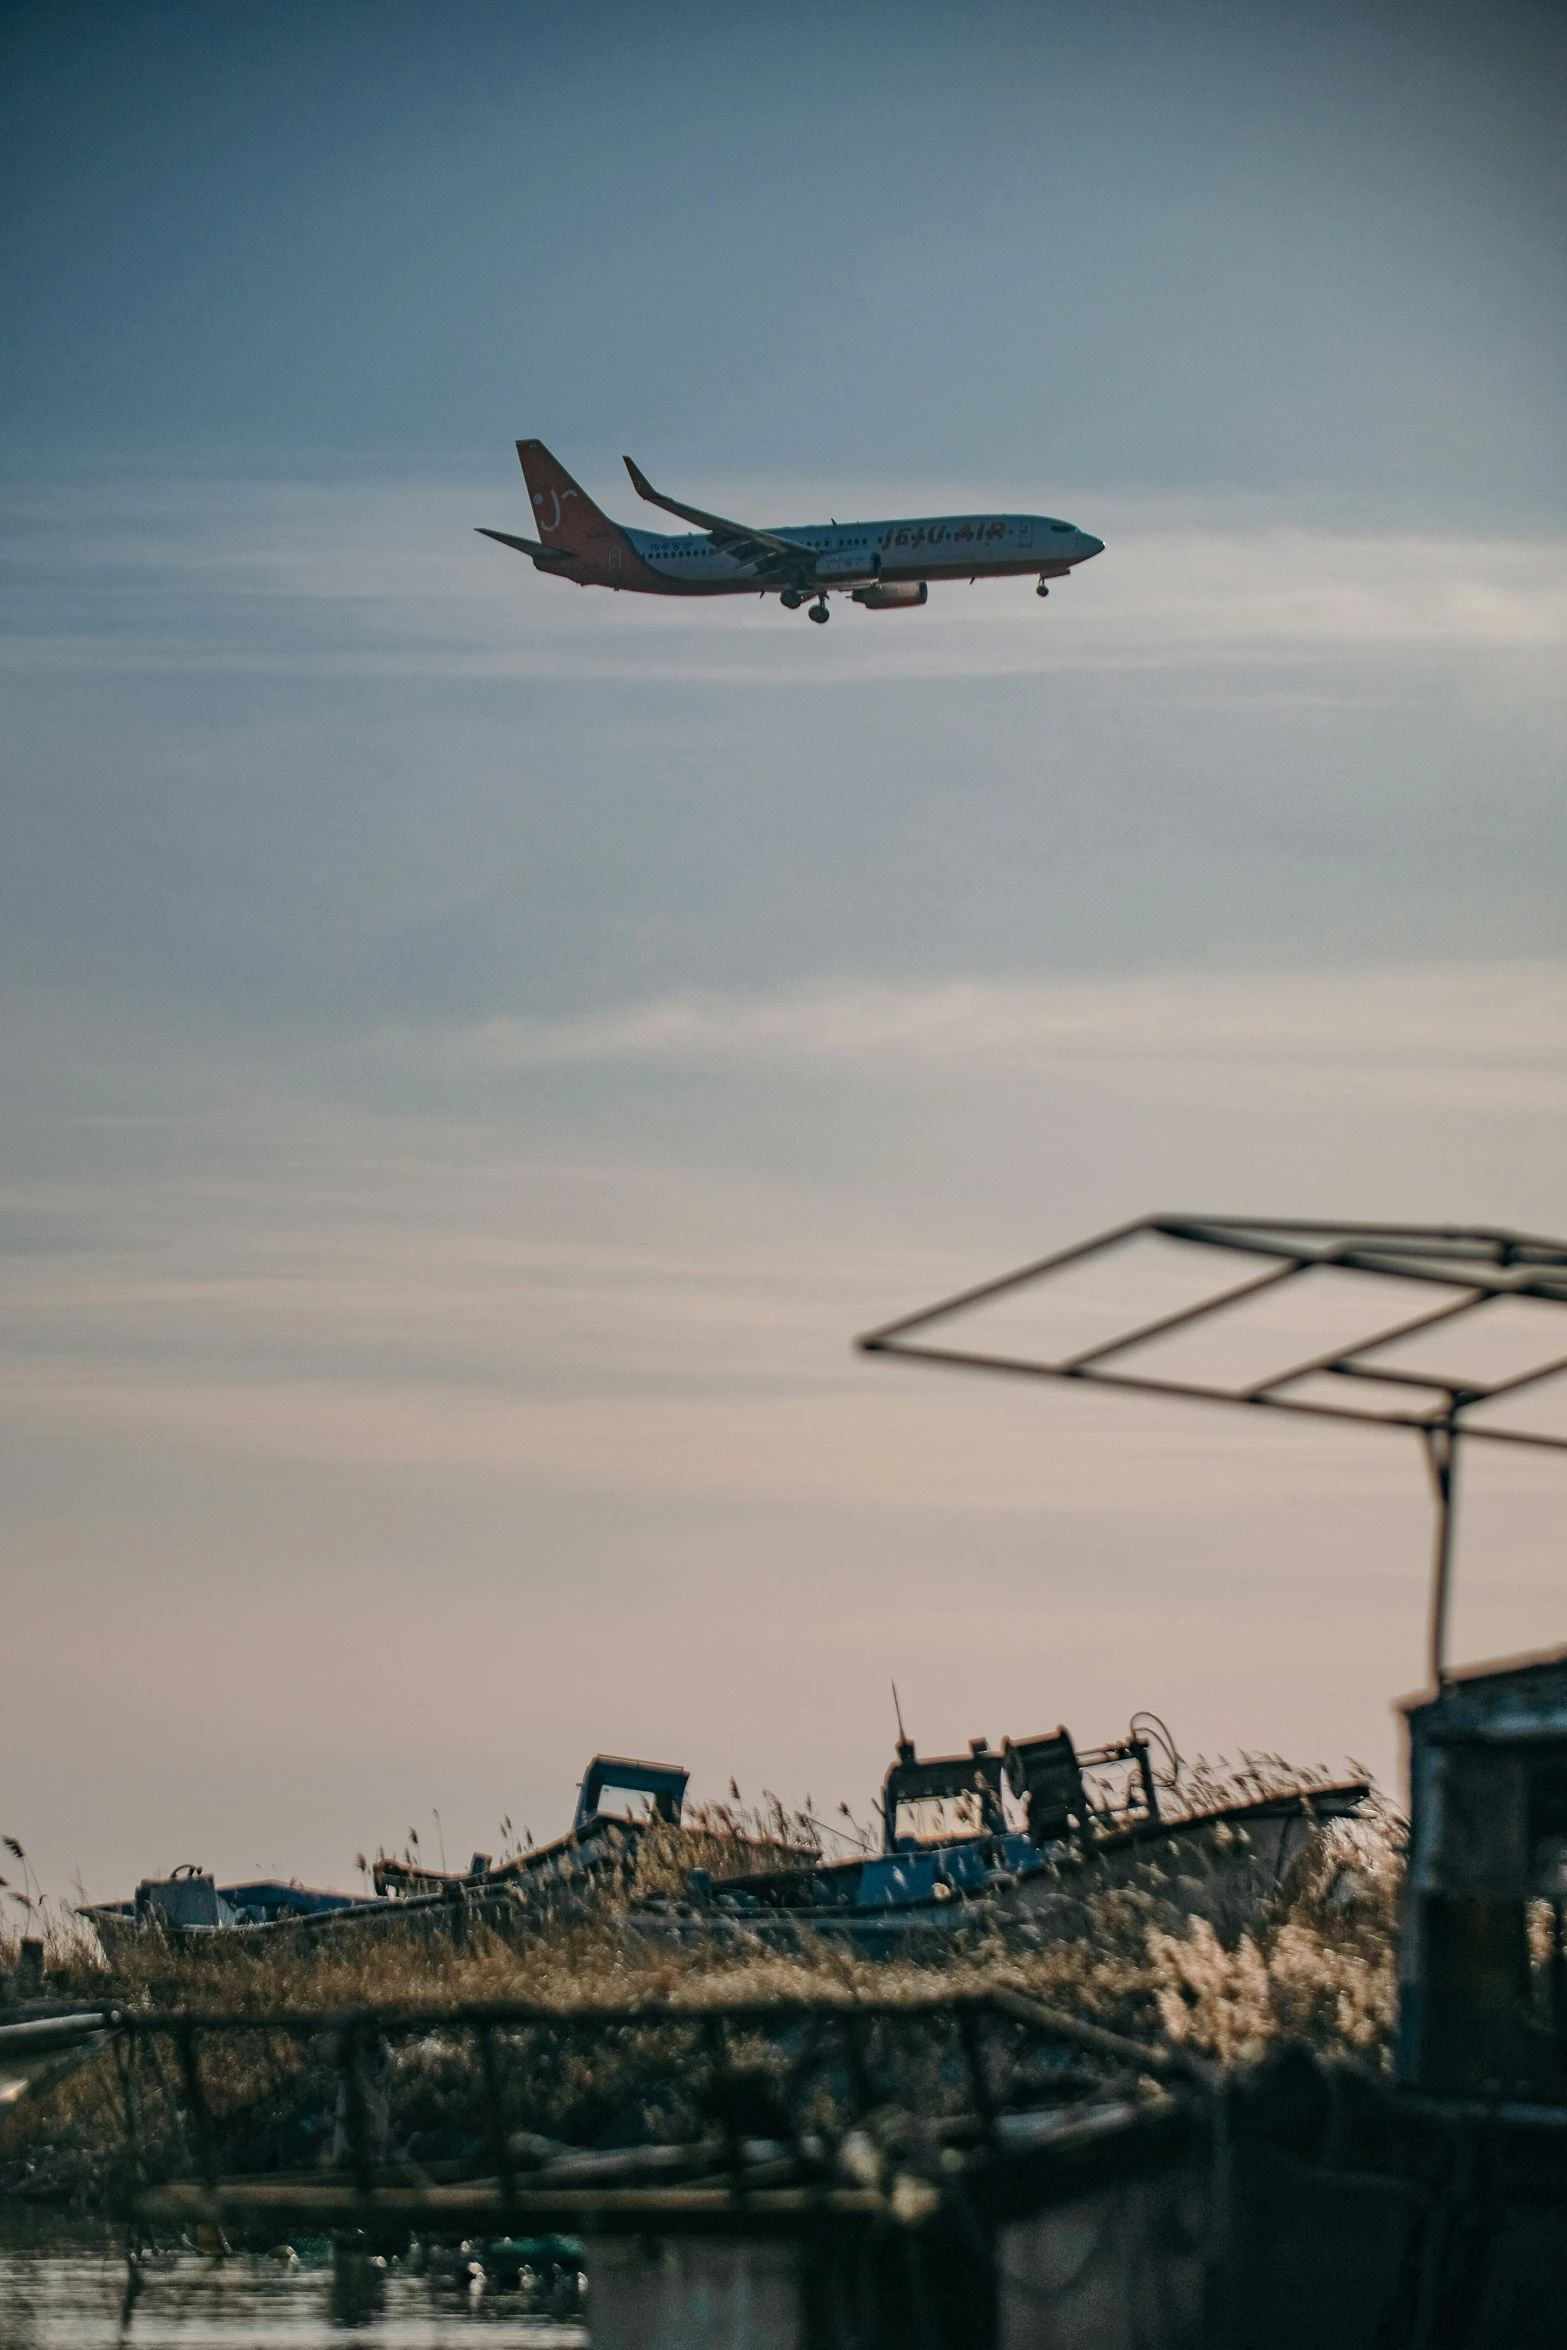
[0,1785,1403,2059]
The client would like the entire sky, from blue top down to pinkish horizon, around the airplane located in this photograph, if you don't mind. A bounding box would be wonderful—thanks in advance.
[0,5,1567,1892]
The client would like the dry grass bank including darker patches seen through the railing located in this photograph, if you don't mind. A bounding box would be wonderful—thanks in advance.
[0,1810,1403,2195]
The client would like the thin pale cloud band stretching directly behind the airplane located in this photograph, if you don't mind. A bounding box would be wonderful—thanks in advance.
[0,482,1567,684]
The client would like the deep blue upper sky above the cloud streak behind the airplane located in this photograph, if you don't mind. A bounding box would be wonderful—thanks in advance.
[5,0,1565,524]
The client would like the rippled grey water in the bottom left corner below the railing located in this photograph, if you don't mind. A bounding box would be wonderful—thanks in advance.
[0,2211,587,2350]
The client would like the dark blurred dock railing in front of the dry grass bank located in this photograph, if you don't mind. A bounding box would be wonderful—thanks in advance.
[82,1988,1212,2242]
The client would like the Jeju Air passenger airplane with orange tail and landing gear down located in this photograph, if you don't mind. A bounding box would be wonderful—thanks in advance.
[479,442,1104,620]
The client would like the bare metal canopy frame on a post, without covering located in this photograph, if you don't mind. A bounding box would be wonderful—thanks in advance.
[855,1215,1567,1687]
